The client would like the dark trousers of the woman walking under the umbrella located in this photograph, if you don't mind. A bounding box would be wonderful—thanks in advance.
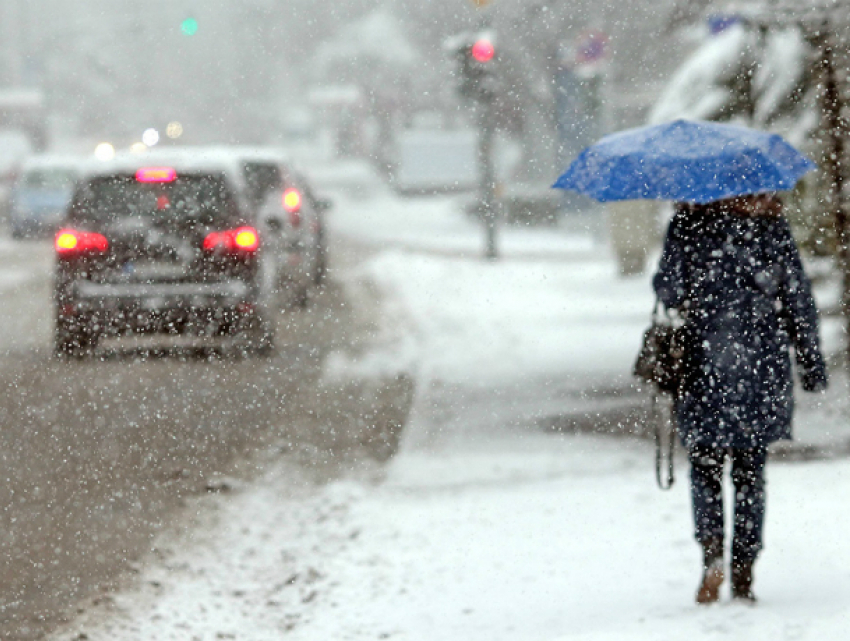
[689,446,767,561]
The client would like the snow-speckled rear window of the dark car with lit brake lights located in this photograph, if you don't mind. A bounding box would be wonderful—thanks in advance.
[71,175,239,225]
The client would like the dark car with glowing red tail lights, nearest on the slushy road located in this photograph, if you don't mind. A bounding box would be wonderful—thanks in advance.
[55,160,273,355]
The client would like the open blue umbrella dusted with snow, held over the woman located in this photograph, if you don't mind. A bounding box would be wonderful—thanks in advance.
[553,120,816,203]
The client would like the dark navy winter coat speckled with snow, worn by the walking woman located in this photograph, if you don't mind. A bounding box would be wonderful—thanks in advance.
[654,205,826,449]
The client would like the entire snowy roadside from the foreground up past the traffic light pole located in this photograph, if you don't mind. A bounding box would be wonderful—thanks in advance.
[54,164,850,641]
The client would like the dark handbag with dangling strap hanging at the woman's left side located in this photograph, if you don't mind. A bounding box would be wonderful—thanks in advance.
[634,299,686,490]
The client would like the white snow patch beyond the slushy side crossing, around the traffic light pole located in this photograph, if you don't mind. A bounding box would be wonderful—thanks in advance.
[332,178,653,383]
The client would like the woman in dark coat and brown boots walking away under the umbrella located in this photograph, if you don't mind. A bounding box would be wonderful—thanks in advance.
[654,195,827,603]
